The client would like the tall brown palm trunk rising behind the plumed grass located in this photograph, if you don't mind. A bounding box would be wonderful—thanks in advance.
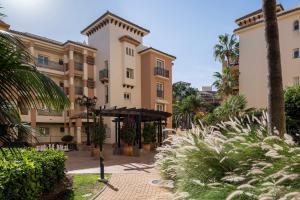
[263,0,286,137]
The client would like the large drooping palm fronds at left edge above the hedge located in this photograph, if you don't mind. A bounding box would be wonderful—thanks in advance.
[0,30,69,146]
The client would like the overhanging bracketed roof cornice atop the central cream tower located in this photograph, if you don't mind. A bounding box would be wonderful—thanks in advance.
[81,11,150,36]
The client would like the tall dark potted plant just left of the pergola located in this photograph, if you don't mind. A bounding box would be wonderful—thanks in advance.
[91,117,106,158]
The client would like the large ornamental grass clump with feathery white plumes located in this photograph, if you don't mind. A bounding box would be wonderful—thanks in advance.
[156,114,300,200]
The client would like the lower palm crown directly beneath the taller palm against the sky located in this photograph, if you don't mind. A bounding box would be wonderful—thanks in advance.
[213,67,238,99]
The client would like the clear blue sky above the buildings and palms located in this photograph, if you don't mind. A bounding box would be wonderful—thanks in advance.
[0,0,300,88]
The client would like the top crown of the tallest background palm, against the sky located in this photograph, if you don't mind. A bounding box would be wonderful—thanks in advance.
[214,34,239,67]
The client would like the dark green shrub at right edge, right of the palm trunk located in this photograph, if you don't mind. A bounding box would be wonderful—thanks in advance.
[284,86,300,142]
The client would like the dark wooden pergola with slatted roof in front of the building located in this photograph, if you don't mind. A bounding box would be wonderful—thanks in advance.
[95,107,172,149]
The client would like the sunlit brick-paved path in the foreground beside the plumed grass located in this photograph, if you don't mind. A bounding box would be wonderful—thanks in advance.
[96,173,172,200]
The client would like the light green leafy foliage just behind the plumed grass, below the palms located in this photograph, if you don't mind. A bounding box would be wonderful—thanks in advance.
[202,95,247,125]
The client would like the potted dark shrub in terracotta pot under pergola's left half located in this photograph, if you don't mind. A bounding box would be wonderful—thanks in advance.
[120,126,135,156]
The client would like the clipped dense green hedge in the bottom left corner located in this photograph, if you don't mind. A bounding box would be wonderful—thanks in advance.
[0,149,66,200]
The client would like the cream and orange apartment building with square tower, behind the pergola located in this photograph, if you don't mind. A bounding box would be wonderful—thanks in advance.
[0,12,176,143]
